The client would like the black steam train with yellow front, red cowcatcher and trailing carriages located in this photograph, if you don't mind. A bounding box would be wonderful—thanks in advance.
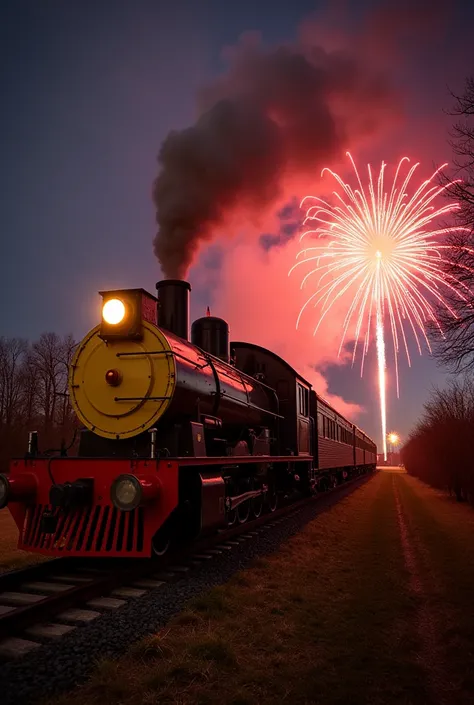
[0,279,377,558]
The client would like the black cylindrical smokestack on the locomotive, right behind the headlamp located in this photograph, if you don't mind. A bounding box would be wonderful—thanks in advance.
[156,279,191,340]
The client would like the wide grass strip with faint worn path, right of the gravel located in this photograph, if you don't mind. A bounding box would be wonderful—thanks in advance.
[48,470,474,705]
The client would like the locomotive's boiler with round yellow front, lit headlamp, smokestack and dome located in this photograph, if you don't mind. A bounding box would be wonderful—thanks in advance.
[70,280,278,456]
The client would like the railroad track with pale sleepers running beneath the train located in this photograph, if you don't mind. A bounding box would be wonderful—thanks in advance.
[0,474,371,660]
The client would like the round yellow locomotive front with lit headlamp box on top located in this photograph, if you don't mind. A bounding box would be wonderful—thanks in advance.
[69,289,176,440]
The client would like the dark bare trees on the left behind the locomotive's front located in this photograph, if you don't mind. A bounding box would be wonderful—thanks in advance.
[0,333,75,472]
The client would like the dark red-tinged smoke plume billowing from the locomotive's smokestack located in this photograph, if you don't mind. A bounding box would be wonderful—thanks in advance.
[153,32,398,277]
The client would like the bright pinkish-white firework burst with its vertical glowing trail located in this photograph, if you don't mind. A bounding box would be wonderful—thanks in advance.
[289,152,470,460]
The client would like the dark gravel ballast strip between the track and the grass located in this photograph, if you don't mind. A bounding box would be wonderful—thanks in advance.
[0,475,371,705]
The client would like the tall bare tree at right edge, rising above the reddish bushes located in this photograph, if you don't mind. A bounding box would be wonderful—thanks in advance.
[434,77,474,372]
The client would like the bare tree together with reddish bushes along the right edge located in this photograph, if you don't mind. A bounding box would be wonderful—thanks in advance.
[402,77,474,490]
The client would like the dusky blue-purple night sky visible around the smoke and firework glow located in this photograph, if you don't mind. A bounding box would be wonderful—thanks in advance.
[0,0,474,446]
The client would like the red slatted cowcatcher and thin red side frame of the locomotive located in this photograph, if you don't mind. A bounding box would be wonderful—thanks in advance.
[5,456,308,558]
